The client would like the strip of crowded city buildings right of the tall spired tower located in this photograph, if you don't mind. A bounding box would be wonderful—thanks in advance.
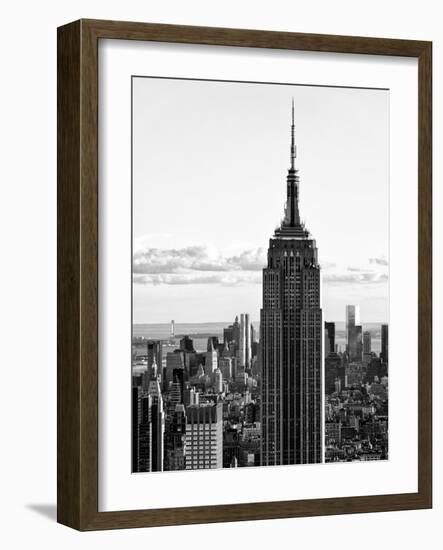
[324,305,389,462]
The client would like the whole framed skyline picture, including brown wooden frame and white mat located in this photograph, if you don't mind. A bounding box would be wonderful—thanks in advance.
[58,20,432,530]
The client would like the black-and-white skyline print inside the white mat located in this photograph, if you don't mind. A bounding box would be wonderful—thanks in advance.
[131,76,389,472]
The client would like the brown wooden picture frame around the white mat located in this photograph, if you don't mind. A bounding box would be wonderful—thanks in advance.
[57,20,432,531]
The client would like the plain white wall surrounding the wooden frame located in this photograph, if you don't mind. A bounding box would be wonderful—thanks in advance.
[0,0,443,550]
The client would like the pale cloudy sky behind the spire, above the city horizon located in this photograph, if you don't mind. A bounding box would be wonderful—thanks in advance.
[133,77,389,323]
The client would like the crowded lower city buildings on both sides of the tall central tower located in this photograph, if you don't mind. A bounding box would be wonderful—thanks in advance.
[132,306,388,472]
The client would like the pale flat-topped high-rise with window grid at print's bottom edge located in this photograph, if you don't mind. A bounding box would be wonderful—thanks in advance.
[186,403,223,470]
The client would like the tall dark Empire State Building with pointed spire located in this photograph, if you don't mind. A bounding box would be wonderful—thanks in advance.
[260,102,322,466]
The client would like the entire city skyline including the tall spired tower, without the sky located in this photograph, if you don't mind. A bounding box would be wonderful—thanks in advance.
[132,106,388,472]
